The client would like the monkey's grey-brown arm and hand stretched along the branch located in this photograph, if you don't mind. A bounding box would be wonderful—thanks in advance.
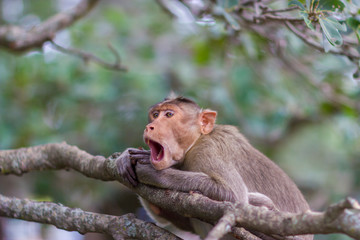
[117,148,276,206]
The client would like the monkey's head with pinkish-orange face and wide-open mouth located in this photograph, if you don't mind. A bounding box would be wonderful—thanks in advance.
[144,97,216,170]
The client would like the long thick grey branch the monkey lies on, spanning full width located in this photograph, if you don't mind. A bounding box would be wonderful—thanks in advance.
[0,143,360,239]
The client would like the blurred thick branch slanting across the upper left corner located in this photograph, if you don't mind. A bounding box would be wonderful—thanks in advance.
[0,0,99,52]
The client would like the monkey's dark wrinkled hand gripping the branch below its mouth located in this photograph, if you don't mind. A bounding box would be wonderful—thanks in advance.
[115,148,150,187]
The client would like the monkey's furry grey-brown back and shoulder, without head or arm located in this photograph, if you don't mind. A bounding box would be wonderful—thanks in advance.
[182,125,309,212]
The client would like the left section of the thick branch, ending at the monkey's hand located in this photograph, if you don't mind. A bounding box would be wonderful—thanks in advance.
[0,142,116,181]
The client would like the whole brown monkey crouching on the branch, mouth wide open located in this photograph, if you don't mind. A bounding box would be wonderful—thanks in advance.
[116,96,313,240]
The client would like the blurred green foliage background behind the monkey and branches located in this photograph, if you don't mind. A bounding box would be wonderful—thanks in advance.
[0,0,360,240]
